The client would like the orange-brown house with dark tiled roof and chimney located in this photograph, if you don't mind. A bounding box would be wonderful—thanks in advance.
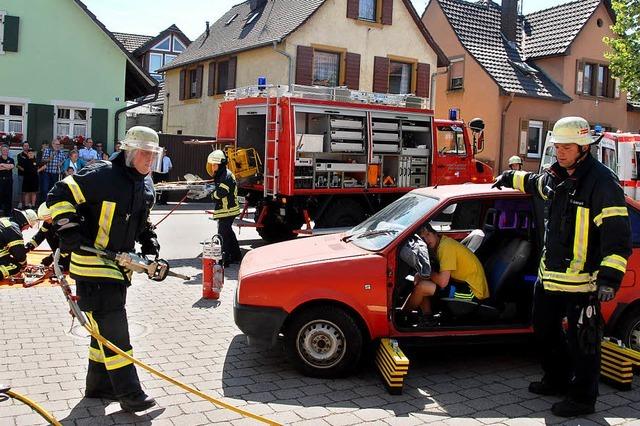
[422,0,640,170]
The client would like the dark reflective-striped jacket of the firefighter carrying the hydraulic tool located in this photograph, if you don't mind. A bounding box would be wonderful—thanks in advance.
[47,153,156,284]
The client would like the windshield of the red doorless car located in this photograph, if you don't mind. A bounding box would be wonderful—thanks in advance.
[343,192,440,251]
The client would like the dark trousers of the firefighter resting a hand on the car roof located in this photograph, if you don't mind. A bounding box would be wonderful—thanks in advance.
[533,282,602,404]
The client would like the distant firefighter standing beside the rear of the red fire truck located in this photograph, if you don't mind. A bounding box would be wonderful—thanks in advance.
[207,149,242,266]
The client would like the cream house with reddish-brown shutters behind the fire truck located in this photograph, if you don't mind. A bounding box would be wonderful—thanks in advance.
[161,0,447,135]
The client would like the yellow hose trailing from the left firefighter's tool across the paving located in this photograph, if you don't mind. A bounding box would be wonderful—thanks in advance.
[53,249,280,425]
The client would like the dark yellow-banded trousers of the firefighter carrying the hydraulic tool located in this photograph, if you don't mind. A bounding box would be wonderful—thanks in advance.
[77,281,142,398]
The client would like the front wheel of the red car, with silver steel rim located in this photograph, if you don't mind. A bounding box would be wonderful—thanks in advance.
[285,306,363,378]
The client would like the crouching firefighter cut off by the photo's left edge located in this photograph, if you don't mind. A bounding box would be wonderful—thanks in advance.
[0,209,38,279]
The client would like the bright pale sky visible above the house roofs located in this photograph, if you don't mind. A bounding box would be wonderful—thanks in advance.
[83,0,571,39]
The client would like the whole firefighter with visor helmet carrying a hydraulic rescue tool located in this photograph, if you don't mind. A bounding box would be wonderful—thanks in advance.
[47,126,162,412]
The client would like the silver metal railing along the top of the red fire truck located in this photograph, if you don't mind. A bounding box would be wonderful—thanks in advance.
[225,84,429,109]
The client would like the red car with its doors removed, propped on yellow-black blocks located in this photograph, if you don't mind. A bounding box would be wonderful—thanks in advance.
[234,184,640,377]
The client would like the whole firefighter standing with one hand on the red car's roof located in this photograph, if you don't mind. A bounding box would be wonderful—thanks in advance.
[494,117,631,417]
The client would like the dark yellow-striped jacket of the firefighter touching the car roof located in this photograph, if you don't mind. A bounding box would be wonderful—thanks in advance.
[505,154,631,293]
